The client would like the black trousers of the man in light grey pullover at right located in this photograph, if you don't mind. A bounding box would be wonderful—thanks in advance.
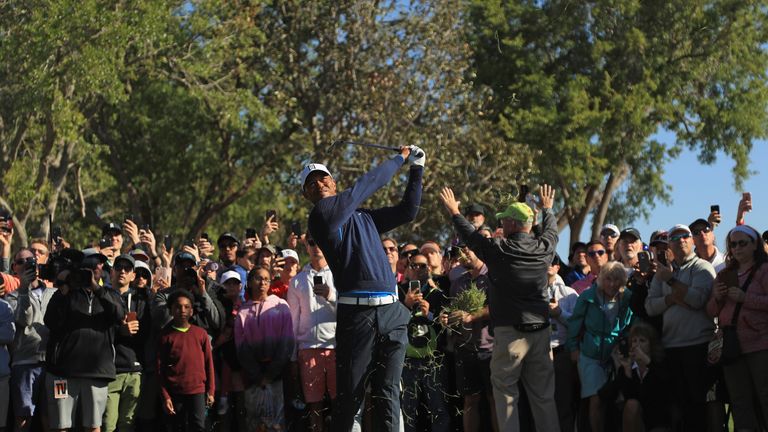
[665,343,712,431]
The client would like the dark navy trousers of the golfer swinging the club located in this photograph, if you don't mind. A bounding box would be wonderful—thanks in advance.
[331,302,410,432]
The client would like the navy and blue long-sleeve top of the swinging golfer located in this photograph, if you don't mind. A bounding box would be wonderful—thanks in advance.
[308,155,424,294]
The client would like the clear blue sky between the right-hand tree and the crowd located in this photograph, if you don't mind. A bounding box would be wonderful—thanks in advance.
[557,141,768,259]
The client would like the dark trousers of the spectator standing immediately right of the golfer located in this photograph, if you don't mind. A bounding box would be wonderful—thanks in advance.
[402,354,451,432]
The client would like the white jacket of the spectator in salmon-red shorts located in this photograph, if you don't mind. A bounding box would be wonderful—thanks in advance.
[285,264,336,360]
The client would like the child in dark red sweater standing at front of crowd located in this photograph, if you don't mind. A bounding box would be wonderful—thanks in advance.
[157,290,215,432]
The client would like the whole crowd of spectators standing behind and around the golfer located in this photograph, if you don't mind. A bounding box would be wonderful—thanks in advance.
[0,185,768,432]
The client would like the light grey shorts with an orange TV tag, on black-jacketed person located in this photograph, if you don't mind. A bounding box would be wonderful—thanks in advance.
[45,373,109,429]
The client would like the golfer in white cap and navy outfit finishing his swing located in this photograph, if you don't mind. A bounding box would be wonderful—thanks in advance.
[301,146,425,432]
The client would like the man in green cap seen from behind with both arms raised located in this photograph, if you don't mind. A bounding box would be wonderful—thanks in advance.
[440,185,560,431]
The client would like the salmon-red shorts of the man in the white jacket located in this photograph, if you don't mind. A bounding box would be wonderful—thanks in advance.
[298,348,336,403]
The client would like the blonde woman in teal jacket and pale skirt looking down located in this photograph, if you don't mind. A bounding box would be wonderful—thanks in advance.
[567,261,633,432]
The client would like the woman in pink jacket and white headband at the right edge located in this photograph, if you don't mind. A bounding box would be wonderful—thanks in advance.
[707,225,768,430]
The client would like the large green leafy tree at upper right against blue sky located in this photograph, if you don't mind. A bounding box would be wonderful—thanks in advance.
[469,0,768,242]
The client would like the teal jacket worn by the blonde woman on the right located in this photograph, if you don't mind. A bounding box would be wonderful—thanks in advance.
[566,283,634,361]
